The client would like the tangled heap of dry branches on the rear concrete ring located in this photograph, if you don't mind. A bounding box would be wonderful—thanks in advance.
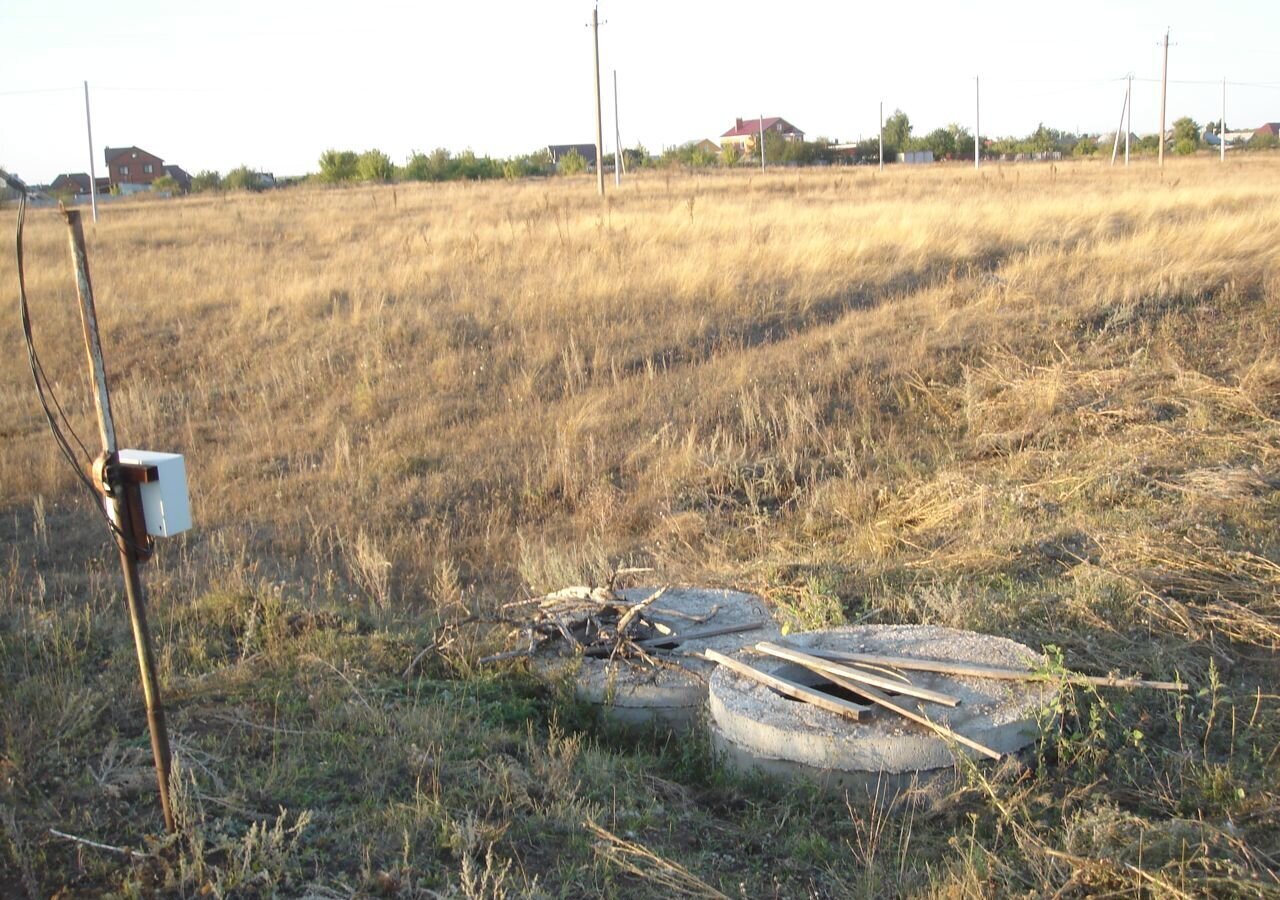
[480,585,760,667]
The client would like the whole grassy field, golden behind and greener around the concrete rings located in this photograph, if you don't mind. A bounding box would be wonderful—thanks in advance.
[0,155,1280,897]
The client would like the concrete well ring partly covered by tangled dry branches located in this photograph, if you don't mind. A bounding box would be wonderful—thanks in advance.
[532,588,780,730]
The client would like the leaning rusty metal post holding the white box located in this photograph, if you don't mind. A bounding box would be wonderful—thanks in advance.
[63,210,175,832]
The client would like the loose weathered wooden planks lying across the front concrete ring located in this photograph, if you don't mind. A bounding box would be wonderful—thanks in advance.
[703,641,1187,759]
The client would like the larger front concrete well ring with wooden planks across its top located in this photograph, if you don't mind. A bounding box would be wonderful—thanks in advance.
[708,625,1057,785]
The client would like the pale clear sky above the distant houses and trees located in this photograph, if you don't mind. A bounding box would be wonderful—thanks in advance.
[0,0,1280,183]
